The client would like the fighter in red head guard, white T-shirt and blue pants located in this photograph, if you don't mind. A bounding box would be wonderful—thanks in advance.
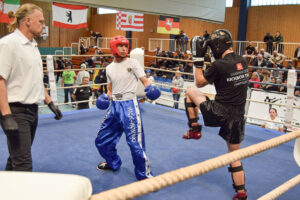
[95,36,160,180]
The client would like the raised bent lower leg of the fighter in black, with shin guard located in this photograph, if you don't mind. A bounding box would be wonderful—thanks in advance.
[183,87,206,139]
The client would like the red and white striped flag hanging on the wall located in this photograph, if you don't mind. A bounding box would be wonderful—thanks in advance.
[116,11,144,32]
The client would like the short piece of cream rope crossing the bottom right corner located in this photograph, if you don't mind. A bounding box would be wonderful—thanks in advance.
[257,174,300,200]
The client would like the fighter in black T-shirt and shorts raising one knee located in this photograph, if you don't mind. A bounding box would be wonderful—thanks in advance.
[183,29,249,200]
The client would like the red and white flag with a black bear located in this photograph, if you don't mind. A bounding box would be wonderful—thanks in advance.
[52,3,88,29]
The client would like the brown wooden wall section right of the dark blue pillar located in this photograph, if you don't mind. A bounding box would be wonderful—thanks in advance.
[247,5,300,43]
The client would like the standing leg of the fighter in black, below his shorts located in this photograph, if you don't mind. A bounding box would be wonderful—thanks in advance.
[227,142,248,200]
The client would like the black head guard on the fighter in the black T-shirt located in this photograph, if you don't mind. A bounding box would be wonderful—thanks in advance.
[207,29,232,59]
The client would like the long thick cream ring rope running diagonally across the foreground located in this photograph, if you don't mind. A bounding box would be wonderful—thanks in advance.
[91,131,300,200]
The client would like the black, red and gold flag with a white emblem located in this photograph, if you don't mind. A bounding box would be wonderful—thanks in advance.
[157,16,179,35]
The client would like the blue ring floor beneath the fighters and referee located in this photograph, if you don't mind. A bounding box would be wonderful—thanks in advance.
[0,103,300,200]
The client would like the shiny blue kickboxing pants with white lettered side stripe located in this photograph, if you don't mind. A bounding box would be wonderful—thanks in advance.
[95,99,152,180]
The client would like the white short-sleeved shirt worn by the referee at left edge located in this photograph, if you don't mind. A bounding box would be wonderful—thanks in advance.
[0,29,45,104]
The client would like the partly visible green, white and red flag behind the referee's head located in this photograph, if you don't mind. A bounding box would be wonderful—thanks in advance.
[0,0,20,23]
